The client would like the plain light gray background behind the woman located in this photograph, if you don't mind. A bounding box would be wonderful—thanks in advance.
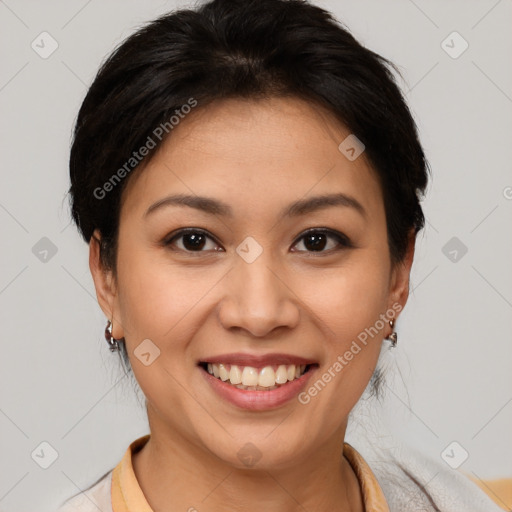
[0,0,512,512]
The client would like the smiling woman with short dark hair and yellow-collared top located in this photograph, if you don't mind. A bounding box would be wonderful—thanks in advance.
[57,0,508,512]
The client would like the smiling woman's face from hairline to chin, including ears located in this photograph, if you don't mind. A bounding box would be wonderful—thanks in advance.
[91,99,413,468]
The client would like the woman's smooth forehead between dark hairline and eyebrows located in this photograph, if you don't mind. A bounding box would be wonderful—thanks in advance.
[123,98,382,221]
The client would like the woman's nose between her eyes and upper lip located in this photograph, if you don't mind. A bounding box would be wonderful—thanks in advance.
[219,251,300,337]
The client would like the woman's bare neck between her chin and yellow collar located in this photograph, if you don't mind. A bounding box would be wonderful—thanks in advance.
[132,418,364,512]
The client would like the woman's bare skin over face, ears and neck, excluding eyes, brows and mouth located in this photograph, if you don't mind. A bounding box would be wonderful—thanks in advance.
[90,98,414,512]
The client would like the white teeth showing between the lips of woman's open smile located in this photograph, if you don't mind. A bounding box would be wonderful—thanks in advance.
[199,362,318,391]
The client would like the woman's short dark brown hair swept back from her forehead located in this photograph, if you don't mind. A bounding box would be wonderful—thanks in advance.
[69,0,429,274]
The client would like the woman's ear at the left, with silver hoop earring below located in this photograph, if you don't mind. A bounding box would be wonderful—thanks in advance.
[89,229,124,339]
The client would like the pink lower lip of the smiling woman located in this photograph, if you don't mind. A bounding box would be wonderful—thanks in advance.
[199,366,316,411]
